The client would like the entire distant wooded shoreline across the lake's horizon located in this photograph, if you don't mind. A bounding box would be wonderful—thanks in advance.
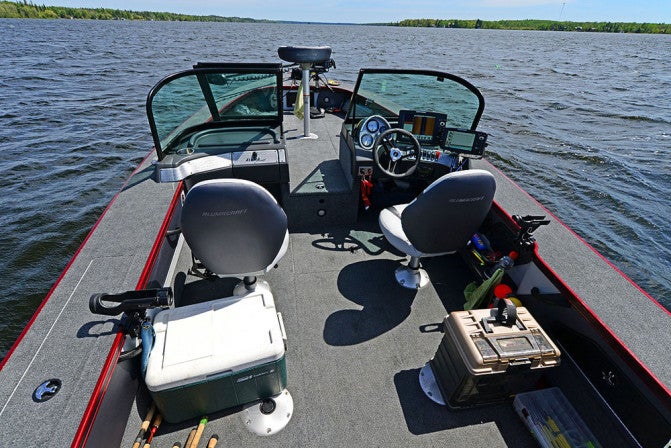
[0,1,671,34]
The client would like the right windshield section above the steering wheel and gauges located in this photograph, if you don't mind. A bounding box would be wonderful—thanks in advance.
[348,69,484,130]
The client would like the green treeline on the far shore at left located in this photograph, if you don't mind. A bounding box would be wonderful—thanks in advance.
[0,0,267,22]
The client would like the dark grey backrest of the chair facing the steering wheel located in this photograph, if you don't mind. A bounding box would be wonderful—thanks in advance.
[401,170,496,254]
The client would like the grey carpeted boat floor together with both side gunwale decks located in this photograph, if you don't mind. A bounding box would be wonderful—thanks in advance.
[0,110,671,447]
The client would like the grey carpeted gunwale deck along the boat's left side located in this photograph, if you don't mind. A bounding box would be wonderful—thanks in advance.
[0,157,176,447]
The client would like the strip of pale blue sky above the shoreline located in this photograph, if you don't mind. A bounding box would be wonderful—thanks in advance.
[33,0,671,23]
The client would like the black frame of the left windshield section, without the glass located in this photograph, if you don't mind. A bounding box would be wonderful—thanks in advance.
[146,62,284,160]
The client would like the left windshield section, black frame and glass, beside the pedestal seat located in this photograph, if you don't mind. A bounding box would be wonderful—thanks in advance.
[147,64,282,159]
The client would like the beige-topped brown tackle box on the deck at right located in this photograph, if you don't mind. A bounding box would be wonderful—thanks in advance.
[429,306,560,408]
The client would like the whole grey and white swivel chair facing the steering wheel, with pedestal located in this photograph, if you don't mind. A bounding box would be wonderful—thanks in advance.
[379,170,496,289]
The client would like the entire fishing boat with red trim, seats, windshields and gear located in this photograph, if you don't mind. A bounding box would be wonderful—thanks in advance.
[0,47,671,447]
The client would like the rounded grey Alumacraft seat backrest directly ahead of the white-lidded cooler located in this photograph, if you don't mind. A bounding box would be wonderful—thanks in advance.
[181,179,289,277]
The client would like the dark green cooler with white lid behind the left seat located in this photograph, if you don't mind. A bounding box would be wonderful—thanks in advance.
[145,291,287,423]
